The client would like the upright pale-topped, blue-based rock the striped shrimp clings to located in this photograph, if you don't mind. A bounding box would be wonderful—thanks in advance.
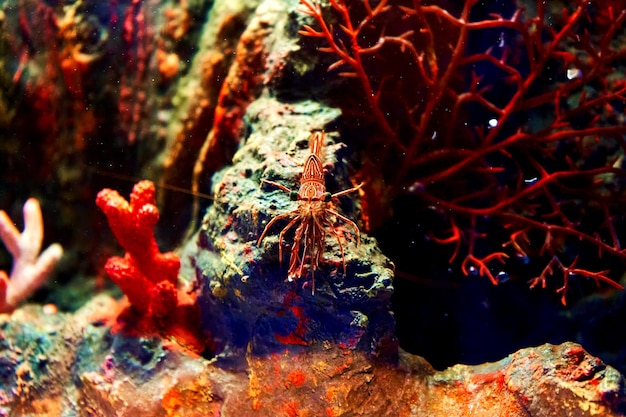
[185,99,397,358]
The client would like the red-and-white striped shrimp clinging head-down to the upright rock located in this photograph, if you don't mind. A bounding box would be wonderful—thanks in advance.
[257,132,363,295]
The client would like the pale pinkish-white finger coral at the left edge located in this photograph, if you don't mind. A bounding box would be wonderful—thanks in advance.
[0,198,63,313]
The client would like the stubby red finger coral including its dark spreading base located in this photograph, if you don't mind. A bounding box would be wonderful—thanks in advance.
[96,181,210,353]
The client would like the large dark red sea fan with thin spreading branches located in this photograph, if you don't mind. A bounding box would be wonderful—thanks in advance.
[301,0,626,303]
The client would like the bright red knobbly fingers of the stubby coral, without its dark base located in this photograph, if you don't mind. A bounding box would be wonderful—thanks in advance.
[96,181,180,318]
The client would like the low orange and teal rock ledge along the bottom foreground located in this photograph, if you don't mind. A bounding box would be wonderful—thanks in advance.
[0,296,626,417]
